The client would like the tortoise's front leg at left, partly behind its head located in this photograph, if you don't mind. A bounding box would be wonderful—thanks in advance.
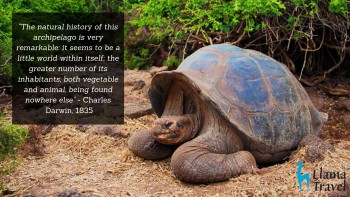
[128,130,174,160]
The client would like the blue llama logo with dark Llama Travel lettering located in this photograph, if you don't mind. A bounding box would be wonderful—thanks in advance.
[297,161,346,191]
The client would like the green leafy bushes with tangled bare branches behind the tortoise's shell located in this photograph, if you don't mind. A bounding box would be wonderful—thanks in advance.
[124,0,350,82]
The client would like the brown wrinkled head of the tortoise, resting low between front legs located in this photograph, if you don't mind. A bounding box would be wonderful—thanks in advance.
[152,115,197,144]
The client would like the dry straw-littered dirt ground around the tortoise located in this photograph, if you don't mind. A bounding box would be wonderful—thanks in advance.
[0,71,350,196]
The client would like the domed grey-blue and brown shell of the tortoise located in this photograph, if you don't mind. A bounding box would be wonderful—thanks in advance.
[149,44,325,151]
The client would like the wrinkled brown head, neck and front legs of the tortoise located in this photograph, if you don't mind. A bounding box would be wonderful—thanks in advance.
[129,84,256,183]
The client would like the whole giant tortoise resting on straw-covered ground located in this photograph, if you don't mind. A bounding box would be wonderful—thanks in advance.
[128,44,327,183]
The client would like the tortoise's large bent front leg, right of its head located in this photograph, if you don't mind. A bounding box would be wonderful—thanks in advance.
[171,133,256,183]
